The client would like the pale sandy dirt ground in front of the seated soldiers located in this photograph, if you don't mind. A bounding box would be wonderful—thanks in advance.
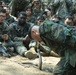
[0,55,60,75]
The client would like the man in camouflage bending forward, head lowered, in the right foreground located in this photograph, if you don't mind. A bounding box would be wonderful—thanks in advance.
[28,20,76,75]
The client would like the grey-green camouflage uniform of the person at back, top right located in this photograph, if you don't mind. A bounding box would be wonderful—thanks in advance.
[48,0,72,20]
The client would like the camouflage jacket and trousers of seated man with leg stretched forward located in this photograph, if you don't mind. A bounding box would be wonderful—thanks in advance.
[9,22,30,55]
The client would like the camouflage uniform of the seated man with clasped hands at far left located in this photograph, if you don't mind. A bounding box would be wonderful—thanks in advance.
[0,22,13,56]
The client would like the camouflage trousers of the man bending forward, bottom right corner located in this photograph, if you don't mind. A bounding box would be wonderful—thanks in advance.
[53,58,76,75]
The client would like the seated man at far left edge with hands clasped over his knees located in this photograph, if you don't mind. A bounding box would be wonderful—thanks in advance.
[0,9,13,56]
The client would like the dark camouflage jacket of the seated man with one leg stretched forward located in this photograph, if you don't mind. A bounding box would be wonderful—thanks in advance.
[8,22,30,40]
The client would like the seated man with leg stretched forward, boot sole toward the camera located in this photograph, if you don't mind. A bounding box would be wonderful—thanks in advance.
[9,12,37,59]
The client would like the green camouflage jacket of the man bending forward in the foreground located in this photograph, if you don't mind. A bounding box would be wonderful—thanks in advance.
[39,20,76,67]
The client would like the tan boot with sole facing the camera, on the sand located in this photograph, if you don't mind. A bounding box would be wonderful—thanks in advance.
[24,47,37,59]
